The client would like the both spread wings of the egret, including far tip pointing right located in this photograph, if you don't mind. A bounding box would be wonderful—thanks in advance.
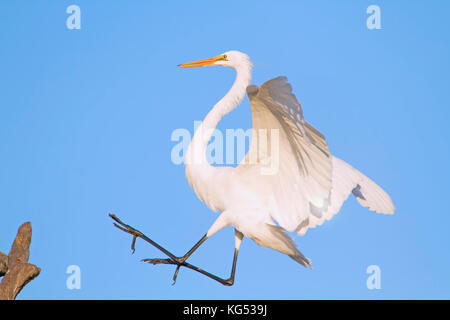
[239,77,395,235]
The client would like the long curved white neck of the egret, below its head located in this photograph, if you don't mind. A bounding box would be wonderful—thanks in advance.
[185,61,252,206]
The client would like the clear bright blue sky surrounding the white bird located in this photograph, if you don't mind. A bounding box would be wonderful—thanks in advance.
[0,0,450,299]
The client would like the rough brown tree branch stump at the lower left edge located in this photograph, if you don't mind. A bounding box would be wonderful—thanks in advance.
[0,222,41,300]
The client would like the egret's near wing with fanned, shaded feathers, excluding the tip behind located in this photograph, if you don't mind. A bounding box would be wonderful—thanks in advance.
[243,77,333,233]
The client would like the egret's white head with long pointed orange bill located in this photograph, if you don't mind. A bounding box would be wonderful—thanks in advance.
[178,50,252,69]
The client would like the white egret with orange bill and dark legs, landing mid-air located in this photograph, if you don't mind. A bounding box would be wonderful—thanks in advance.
[145,51,395,285]
